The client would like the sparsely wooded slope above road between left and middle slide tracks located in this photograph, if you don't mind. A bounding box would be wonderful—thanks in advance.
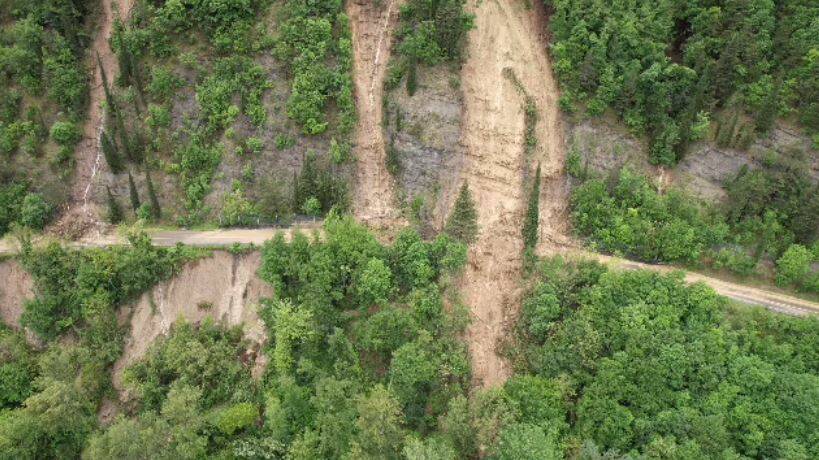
[103,0,355,226]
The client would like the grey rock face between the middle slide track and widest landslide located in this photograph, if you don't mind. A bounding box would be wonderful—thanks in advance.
[385,66,464,232]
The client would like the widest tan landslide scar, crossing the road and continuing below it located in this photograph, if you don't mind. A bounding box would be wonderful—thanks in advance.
[461,0,567,387]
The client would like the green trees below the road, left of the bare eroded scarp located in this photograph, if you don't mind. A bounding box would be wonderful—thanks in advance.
[0,234,196,459]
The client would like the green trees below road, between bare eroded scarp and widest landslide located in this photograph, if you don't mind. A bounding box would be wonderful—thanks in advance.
[78,214,491,459]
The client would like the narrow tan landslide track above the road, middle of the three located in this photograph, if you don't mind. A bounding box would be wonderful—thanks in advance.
[347,0,402,228]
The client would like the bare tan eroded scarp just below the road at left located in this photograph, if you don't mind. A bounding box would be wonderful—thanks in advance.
[113,251,273,390]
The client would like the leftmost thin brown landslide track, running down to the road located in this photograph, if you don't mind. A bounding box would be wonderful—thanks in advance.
[52,0,133,238]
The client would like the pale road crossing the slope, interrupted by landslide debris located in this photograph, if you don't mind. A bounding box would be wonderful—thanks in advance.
[0,223,819,316]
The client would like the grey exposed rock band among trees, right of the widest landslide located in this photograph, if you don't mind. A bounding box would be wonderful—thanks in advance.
[567,119,819,200]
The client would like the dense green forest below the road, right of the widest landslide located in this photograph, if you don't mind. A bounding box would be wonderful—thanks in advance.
[510,260,819,459]
